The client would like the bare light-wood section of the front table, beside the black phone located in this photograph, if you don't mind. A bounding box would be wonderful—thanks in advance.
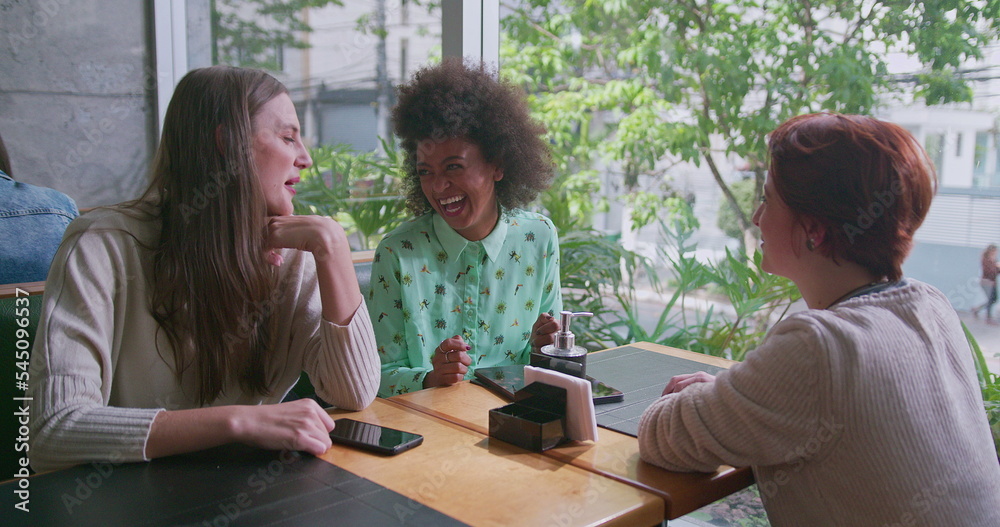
[320,399,663,526]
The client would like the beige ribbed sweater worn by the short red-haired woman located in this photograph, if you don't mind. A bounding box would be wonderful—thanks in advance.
[639,280,1000,527]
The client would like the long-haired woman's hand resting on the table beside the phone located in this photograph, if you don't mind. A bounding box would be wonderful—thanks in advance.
[233,399,334,456]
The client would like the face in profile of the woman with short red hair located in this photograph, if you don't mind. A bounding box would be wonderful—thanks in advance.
[753,177,805,281]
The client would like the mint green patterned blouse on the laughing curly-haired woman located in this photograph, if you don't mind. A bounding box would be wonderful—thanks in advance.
[368,209,562,397]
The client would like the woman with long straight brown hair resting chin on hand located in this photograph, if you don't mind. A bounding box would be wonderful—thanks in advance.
[29,66,379,470]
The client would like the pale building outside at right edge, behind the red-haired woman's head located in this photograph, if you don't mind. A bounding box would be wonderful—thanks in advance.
[879,44,1000,309]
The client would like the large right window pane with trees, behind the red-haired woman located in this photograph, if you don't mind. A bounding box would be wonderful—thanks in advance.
[492,0,1000,364]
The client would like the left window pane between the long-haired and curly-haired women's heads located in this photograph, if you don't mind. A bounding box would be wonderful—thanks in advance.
[167,0,446,250]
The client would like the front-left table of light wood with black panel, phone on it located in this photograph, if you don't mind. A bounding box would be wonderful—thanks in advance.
[0,399,663,527]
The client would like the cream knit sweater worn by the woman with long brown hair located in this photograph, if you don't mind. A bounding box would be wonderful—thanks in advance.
[28,210,380,471]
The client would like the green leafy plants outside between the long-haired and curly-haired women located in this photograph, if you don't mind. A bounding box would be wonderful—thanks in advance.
[294,141,406,250]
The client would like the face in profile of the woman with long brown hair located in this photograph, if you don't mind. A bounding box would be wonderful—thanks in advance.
[253,93,312,216]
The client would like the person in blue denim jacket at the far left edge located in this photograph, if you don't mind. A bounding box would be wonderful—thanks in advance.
[0,134,79,284]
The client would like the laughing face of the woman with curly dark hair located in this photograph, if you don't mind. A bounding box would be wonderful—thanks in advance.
[417,137,503,241]
